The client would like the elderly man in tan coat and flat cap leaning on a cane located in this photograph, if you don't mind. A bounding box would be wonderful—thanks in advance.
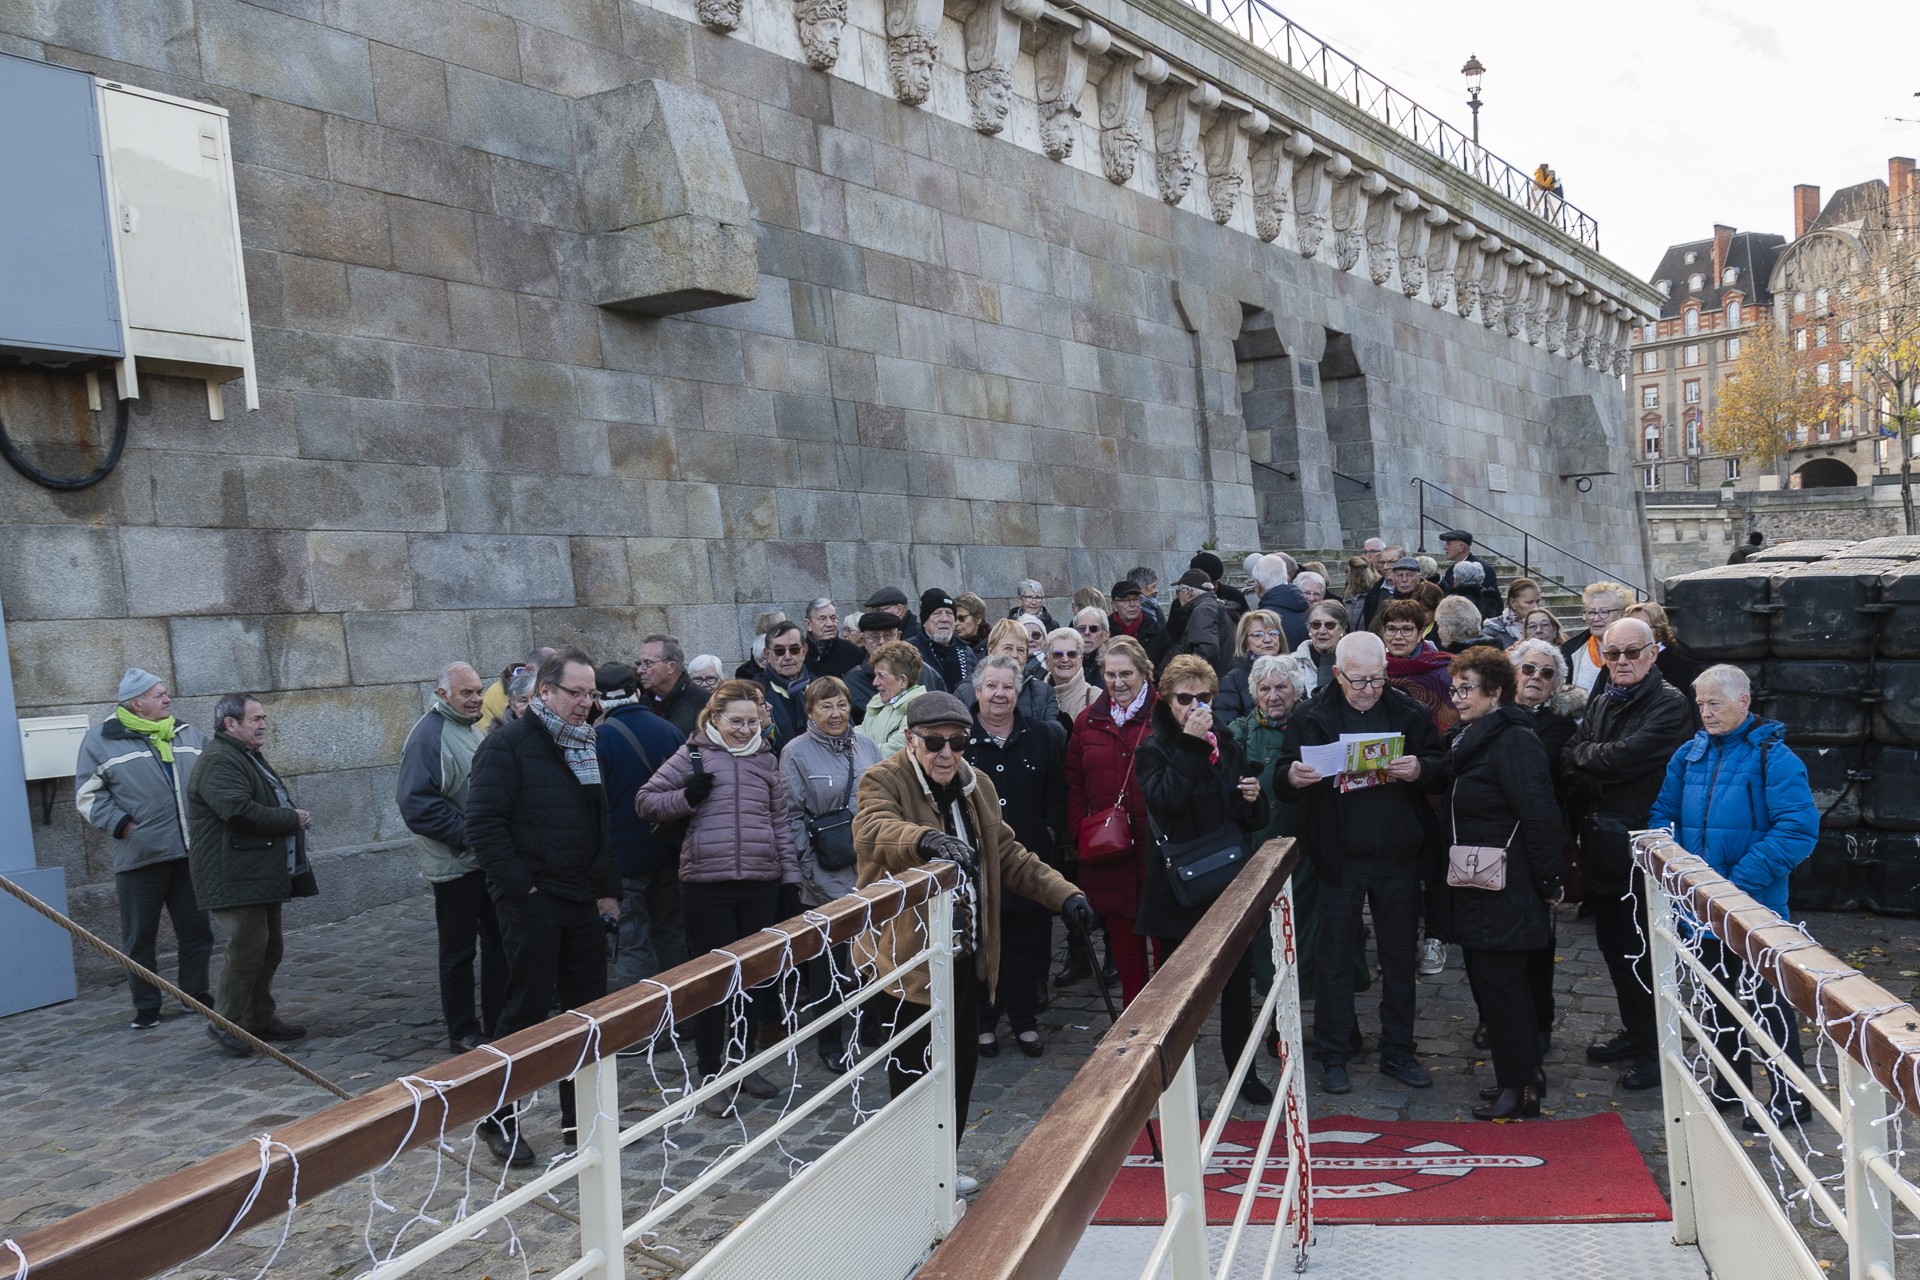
[852,693,1094,1194]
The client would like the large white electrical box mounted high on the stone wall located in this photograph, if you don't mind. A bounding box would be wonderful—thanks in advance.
[94,81,259,418]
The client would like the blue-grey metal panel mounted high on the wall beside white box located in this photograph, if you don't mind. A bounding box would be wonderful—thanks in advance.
[0,54,121,363]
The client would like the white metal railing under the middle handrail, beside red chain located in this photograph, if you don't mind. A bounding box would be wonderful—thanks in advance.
[1140,881,1313,1280]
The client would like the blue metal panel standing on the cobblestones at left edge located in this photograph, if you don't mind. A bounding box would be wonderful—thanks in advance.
[0,587,73,1017]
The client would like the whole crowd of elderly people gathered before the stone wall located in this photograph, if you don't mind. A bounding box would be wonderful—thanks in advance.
[77,530,1818,1165]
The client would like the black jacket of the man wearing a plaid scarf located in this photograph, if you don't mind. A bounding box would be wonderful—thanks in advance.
[467,714,620,902]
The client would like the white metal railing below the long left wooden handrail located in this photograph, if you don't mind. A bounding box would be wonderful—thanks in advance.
[361,890,958,1280]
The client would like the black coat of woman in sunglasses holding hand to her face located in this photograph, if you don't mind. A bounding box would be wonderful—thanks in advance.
[1133,702,1267,938]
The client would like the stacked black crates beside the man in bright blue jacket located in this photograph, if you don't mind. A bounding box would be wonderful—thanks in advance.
[1665,537,1920,915]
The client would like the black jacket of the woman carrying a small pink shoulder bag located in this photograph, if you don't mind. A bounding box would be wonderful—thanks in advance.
[1442,706,1567,952]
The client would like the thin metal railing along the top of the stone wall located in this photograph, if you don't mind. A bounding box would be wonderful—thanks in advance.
[1183,0,1599,249]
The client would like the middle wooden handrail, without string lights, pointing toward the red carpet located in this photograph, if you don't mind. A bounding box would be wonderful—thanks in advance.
[918,839,1300,1280]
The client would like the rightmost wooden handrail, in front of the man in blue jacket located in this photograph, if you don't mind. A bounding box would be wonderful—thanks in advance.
[1634,831,1920,1115]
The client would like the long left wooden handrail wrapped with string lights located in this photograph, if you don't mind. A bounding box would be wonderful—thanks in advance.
[0,862,960,1280]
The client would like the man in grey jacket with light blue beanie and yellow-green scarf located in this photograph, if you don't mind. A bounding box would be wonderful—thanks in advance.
[73,668,213,1031]
